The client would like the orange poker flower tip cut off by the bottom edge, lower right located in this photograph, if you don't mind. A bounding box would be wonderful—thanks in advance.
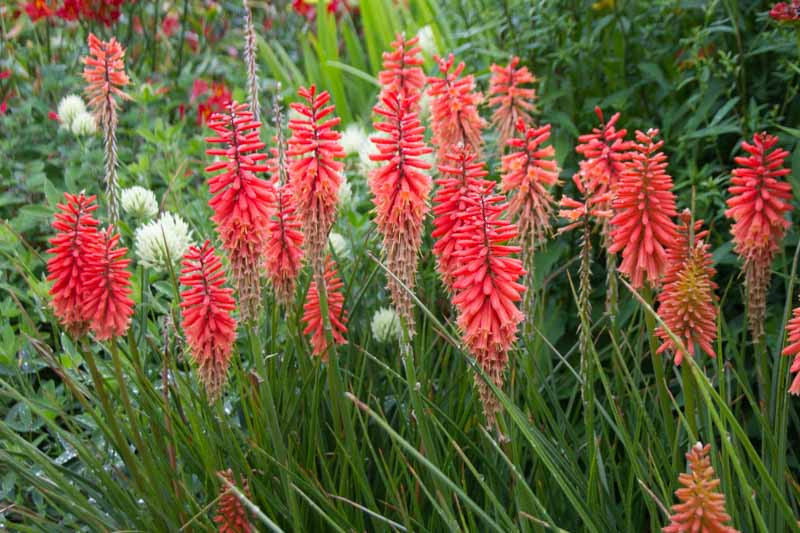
[662,442,738,533]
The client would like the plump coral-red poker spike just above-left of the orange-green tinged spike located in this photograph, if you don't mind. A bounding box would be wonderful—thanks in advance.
[608,129,677,289]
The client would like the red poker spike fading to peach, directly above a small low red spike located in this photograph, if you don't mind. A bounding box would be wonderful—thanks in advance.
[287,85,345,271]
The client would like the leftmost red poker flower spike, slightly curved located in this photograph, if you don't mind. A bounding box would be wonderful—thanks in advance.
[47,193,99,337]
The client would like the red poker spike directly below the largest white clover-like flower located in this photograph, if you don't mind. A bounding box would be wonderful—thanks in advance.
[180,241,236,401]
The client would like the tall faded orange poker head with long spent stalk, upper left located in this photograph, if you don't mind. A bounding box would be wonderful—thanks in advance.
[83,33,130,224]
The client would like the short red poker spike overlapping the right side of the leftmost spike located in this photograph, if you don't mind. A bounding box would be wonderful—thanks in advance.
[83,227,133,340]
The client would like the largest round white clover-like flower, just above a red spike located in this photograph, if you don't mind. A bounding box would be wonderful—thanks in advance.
[134,213,192,272]
